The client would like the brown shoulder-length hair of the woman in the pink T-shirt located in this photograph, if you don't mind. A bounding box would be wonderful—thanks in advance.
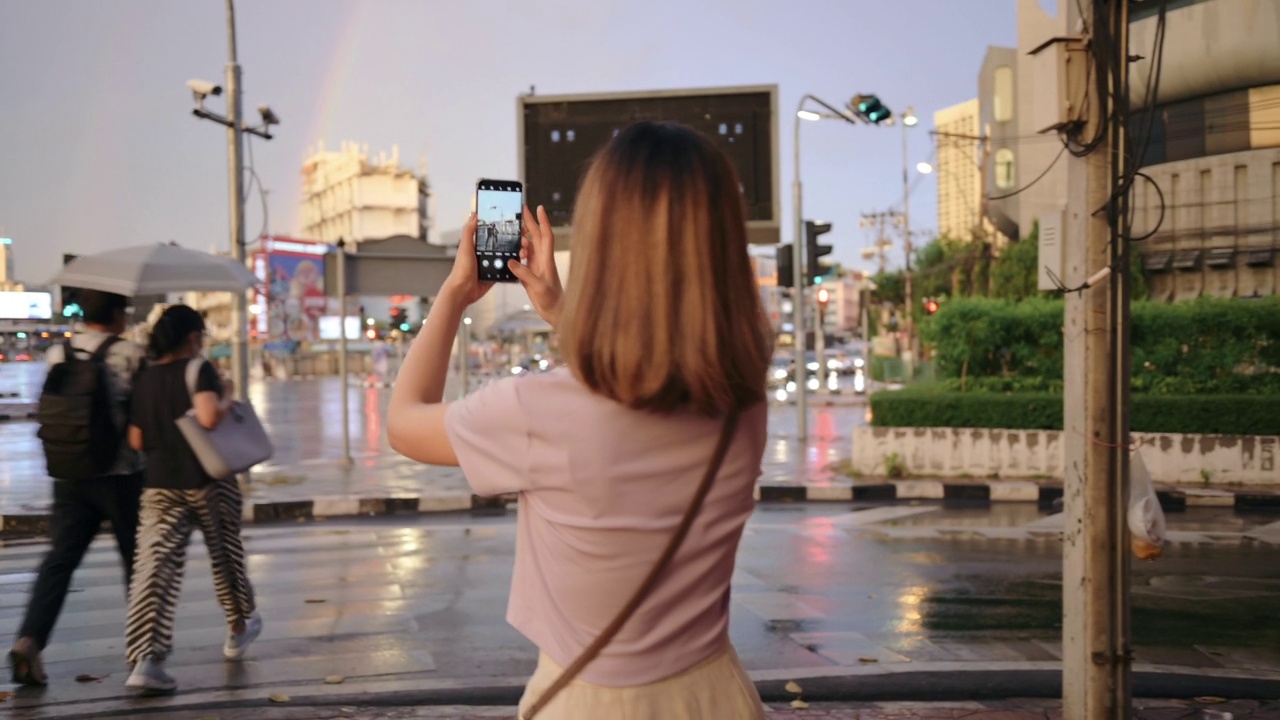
[559,122,772,416]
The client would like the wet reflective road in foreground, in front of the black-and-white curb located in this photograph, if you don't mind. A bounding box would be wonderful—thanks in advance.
[0,505,1280,717]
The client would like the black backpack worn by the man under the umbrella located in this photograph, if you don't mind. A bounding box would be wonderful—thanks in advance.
[36,336,124,480]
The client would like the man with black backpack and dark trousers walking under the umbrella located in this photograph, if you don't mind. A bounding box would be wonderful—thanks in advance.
[9,290,146,685]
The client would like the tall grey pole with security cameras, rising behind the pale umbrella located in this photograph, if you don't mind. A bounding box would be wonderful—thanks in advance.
[187,0,279,400]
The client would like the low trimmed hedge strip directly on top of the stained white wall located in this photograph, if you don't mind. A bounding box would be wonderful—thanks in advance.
[870,389,1280,436]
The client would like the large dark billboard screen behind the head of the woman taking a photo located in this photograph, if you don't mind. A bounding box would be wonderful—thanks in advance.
[517,86,781,243]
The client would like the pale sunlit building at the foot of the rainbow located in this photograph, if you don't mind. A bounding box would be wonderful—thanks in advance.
[300,142,431,245]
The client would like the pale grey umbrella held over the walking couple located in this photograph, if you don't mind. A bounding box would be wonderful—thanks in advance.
[50,243,259,297]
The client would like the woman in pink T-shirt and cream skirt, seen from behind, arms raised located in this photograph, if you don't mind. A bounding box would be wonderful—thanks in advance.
[387,123,771,720]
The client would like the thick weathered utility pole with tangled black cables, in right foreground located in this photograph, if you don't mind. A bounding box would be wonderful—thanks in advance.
[1061,0,1132,720]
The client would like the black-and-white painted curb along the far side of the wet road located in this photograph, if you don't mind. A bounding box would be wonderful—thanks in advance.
[0,480,1280,537]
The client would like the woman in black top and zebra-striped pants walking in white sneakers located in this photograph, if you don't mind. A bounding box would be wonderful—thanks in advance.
[125,305,262,692]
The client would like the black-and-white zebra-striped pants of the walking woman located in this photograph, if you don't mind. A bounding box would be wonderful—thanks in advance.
[125,478,253,664]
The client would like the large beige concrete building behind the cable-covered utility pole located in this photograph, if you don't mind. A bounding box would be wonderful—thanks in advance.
[997,0,1280,300]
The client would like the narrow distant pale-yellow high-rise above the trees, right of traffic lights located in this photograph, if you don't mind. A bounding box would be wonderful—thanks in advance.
[933,99,982,241]
